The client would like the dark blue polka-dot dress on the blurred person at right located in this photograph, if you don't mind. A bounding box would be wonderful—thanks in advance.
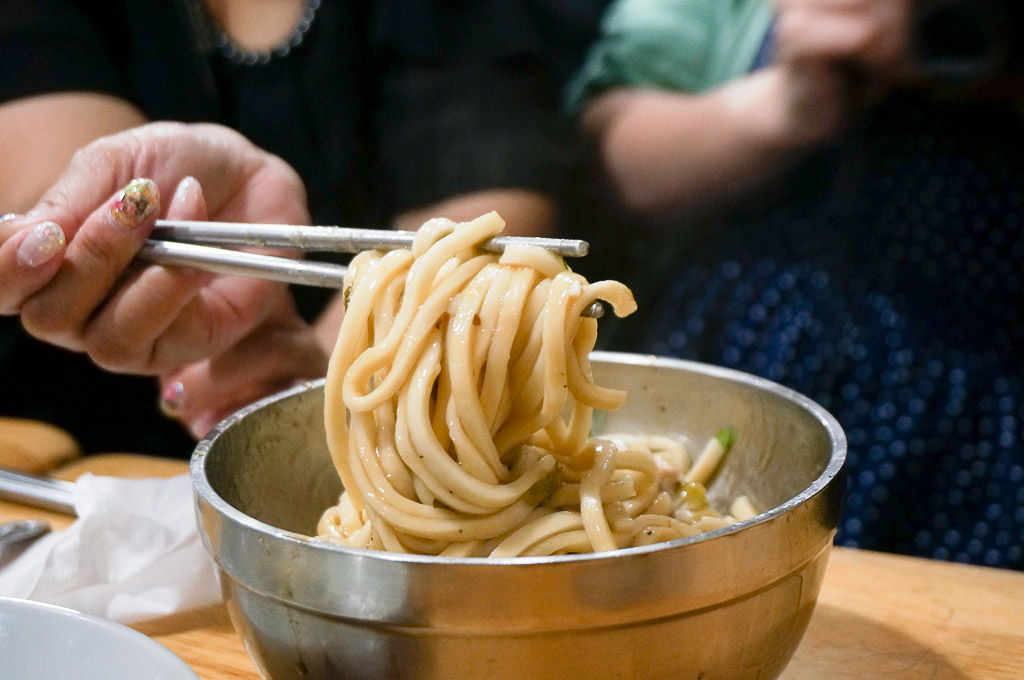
[631,99,1024,569]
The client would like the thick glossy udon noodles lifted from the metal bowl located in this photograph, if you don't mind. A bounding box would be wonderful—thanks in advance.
[317,213,754,557]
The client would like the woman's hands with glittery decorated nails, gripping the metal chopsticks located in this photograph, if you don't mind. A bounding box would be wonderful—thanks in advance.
[0,123,325,436]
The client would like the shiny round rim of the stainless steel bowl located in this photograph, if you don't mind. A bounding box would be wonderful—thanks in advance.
[189,351,848,567]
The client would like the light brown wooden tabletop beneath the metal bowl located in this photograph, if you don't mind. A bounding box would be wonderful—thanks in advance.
[0,457,1024,680]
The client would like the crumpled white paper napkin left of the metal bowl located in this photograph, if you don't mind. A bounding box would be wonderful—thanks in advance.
[0,474,221,624]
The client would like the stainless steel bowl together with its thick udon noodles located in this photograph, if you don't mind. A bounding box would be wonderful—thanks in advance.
[191,216,846,680]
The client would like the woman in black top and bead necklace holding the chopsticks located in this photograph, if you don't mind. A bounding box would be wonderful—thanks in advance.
[0,0,601,456]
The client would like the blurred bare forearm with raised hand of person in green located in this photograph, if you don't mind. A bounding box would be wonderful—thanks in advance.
[583,0,909,212]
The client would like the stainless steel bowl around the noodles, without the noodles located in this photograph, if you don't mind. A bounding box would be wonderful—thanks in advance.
[191,353,846,680]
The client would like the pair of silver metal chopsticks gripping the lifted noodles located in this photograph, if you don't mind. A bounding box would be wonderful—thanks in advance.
[136,220,603,317]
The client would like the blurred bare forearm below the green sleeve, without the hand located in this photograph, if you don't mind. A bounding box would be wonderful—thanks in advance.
[583,68,841,213]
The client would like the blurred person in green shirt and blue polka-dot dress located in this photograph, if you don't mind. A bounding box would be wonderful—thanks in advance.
[569,0,1024,569]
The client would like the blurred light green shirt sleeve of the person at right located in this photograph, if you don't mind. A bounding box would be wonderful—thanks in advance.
[566,0,772,114]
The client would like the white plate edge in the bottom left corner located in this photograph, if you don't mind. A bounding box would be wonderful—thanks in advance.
[0,597,199,680]
